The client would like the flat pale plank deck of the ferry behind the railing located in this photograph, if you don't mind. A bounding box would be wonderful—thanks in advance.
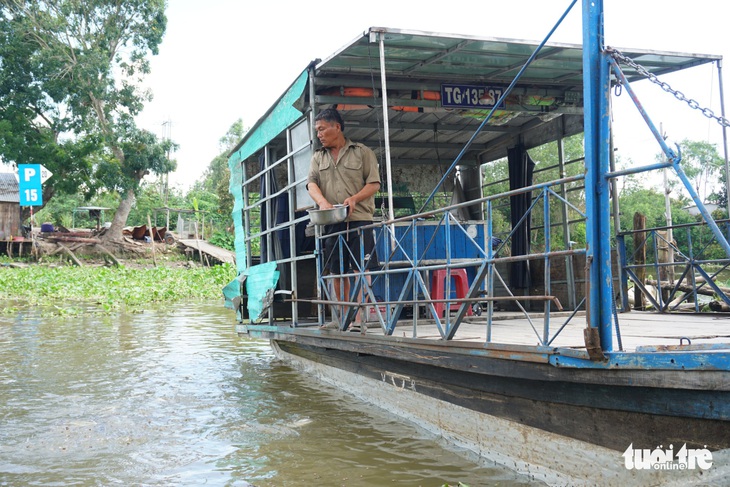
[322,311,730,352]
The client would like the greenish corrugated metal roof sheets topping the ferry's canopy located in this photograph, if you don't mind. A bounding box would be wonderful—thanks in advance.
[317,27,722,88]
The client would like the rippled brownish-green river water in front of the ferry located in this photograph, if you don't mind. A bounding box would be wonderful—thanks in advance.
[0,303,531,487]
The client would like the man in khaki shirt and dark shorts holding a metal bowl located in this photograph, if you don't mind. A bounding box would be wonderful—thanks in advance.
[307,108,380,331]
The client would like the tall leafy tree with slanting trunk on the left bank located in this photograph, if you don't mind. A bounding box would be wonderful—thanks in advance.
[0,0,169,241]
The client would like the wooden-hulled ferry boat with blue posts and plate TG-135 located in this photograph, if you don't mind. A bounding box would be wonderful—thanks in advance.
[224,1,730,486]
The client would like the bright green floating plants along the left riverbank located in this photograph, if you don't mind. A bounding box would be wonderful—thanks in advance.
[0,264,236,315]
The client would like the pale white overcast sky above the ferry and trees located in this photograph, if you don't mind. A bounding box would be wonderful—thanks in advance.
[138,0,730,194]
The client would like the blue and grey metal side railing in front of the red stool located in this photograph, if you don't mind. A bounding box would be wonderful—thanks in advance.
[299,175,585,346]
